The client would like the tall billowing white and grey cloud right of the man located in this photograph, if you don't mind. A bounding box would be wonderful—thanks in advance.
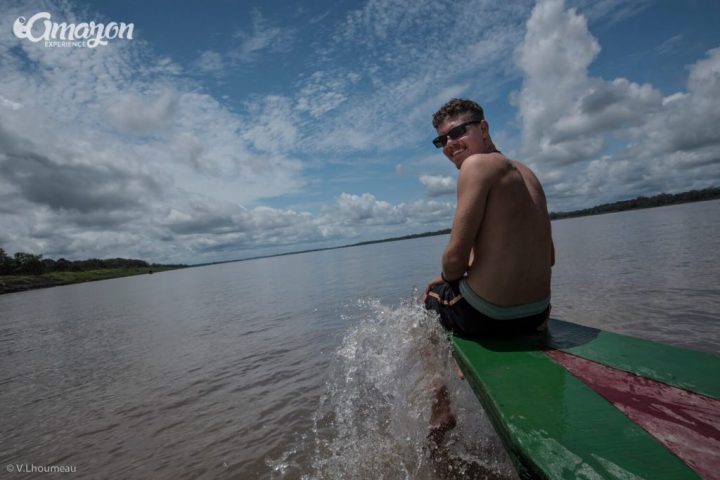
[515,0,720,209]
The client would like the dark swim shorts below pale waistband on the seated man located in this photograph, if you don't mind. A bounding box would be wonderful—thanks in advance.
[425,280,550,337]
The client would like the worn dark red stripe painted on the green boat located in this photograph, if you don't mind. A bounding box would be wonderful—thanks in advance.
[546,350,720,480]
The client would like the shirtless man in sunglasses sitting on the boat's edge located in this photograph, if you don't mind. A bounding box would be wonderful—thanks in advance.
[425,99,555,337]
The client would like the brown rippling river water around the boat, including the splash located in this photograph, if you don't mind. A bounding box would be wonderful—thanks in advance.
[0,201,720,480]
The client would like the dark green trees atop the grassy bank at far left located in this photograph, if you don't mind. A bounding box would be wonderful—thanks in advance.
[0,248,185,275]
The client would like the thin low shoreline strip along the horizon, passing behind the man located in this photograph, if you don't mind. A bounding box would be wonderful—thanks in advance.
[0,187,720,295]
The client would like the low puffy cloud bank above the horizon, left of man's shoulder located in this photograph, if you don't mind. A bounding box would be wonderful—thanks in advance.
[148,193,454,261]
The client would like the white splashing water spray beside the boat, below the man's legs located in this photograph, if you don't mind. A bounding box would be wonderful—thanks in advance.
[302,300,516,480]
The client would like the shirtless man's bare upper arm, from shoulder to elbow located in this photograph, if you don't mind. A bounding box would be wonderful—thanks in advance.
[442,155,500,280]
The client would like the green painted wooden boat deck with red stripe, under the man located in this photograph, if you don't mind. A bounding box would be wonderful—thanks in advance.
[451,320,720,479]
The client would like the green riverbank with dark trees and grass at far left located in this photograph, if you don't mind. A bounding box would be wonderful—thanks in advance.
[0,248,186,294]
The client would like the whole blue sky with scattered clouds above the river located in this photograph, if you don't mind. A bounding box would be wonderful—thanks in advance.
[0,0,720,264]
